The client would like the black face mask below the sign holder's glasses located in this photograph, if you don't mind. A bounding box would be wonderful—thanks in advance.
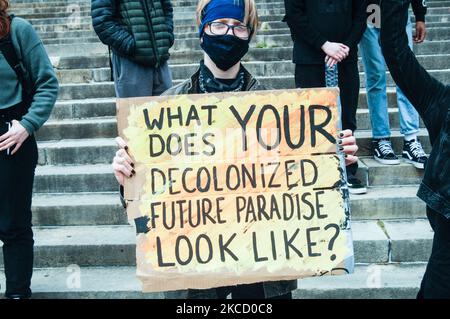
[201,33,250,71]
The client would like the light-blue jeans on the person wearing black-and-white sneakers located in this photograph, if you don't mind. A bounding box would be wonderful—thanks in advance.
[359,16,419,138]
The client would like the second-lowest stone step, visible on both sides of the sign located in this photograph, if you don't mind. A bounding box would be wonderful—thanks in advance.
[0,220,433,268]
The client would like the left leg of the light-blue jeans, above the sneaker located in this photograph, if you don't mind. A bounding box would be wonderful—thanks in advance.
[359,25,391,139]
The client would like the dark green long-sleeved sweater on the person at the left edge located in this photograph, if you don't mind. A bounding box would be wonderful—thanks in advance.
[0,17,58,135]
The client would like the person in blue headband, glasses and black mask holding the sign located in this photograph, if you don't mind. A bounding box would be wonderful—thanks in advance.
[112,0,358,299]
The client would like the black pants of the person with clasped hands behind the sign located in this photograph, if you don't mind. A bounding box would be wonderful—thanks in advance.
[295,61,360,176]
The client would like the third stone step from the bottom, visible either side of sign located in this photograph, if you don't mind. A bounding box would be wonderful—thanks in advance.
[29,185,426,226]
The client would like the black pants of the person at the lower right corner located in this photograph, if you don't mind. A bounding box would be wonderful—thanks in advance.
[417,208,450,299]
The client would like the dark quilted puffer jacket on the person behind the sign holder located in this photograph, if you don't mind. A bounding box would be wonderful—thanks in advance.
[91,0,174,67]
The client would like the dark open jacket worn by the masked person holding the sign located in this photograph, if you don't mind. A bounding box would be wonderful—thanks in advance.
[162,68,297,299]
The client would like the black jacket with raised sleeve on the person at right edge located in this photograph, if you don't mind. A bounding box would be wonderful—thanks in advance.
[381,0,450,218]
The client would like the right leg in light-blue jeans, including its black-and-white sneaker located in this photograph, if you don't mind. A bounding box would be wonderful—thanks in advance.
[397,17,427,169]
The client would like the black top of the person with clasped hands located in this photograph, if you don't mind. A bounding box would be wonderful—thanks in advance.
[283,0,367,64]
